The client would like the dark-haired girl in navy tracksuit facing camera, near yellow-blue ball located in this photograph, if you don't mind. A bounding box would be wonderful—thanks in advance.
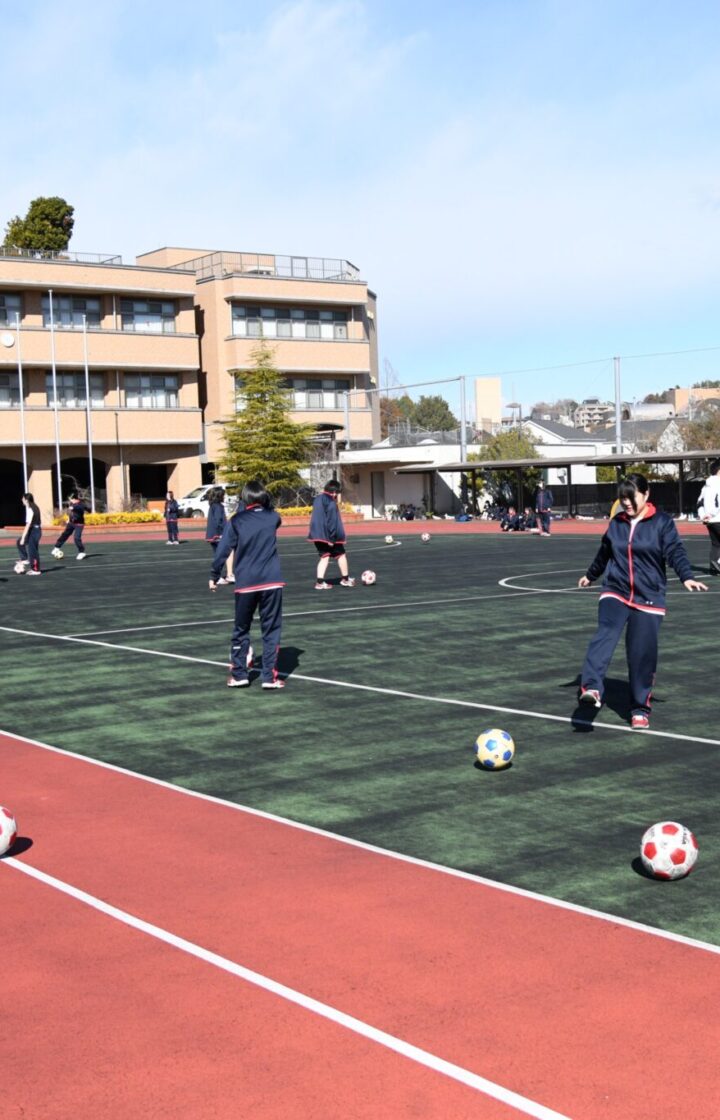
[578,474,708,729]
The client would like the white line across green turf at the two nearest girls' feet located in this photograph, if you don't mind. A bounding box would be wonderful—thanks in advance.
[0,626,720,747]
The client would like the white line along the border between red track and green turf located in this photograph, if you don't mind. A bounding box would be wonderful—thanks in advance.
[0,729,720,955]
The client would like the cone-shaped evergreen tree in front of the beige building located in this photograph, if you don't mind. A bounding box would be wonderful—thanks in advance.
[218,343,315,498]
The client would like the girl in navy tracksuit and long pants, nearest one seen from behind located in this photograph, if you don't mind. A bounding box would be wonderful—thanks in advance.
[209,480,286,689]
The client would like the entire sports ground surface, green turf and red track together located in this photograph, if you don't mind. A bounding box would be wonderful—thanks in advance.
[0,525,720,1120]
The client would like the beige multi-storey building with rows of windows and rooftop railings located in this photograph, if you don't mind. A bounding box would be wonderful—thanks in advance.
[0,249,378,524]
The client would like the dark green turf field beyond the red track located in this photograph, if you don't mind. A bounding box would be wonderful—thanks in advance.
[0,528,720,944]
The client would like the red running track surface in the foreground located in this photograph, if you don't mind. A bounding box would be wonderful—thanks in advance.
[0,735,720,1120]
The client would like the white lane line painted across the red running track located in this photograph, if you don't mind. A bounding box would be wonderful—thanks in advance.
[3,857,569,1120]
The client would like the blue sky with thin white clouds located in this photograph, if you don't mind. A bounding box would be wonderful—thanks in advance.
[0,0,720,418]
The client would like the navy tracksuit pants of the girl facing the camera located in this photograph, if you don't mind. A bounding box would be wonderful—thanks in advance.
[580,598,663,712]
